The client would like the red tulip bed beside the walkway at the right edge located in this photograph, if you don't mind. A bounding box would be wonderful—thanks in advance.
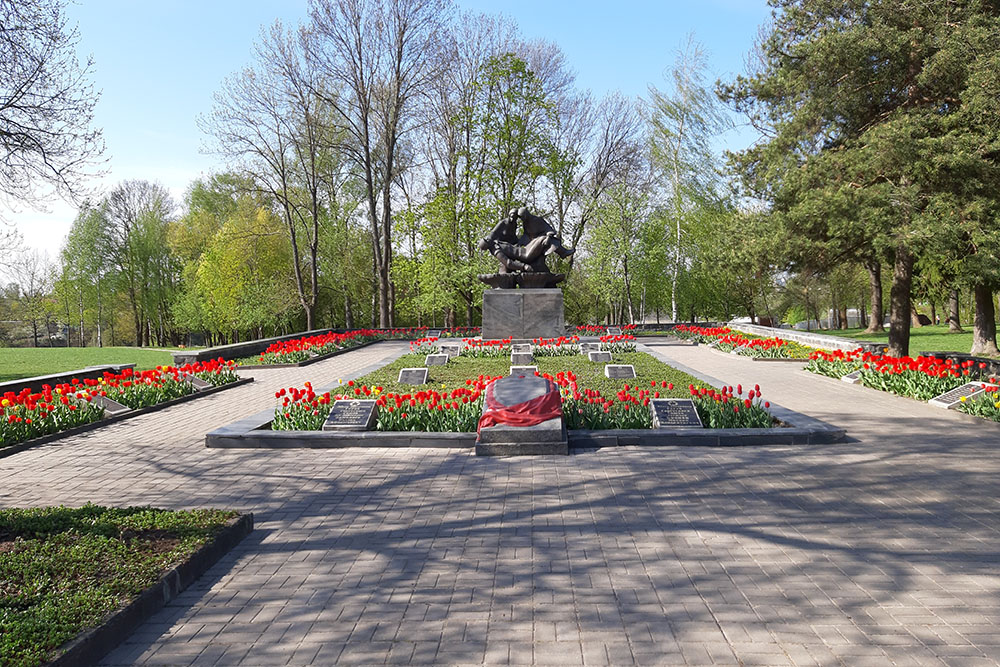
[806,348,995,401]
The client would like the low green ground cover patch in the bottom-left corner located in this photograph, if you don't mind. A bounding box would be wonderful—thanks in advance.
[0,505,237,667]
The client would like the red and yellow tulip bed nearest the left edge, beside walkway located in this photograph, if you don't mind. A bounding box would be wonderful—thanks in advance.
[0,359,239,448]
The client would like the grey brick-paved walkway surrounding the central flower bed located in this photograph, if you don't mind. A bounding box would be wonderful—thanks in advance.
[0,343,1000,666]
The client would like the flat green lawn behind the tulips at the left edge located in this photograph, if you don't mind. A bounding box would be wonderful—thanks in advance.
[0,347,173,382]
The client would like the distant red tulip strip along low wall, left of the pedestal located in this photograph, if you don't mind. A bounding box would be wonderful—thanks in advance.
[236,327,479,366]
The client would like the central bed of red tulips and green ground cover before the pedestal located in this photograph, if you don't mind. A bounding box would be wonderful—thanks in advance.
[271,350,773,432]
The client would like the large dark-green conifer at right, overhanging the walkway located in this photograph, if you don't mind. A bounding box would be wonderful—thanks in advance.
[722,0,1000,356]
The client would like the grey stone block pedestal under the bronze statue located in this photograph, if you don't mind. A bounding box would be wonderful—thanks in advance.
[483,288,566,340]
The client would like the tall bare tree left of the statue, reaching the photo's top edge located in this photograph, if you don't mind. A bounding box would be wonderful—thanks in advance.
[307,0,451,327]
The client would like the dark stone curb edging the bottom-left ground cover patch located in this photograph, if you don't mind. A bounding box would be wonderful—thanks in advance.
[46,513,253,667]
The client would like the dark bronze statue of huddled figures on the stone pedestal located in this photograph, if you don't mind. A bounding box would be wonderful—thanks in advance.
[479,207,574,289]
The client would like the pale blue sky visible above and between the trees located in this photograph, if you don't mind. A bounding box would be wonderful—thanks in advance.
[7,0,770,257]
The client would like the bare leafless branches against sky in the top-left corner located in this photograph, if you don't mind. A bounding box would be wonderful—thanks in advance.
[0,0,104,205]
